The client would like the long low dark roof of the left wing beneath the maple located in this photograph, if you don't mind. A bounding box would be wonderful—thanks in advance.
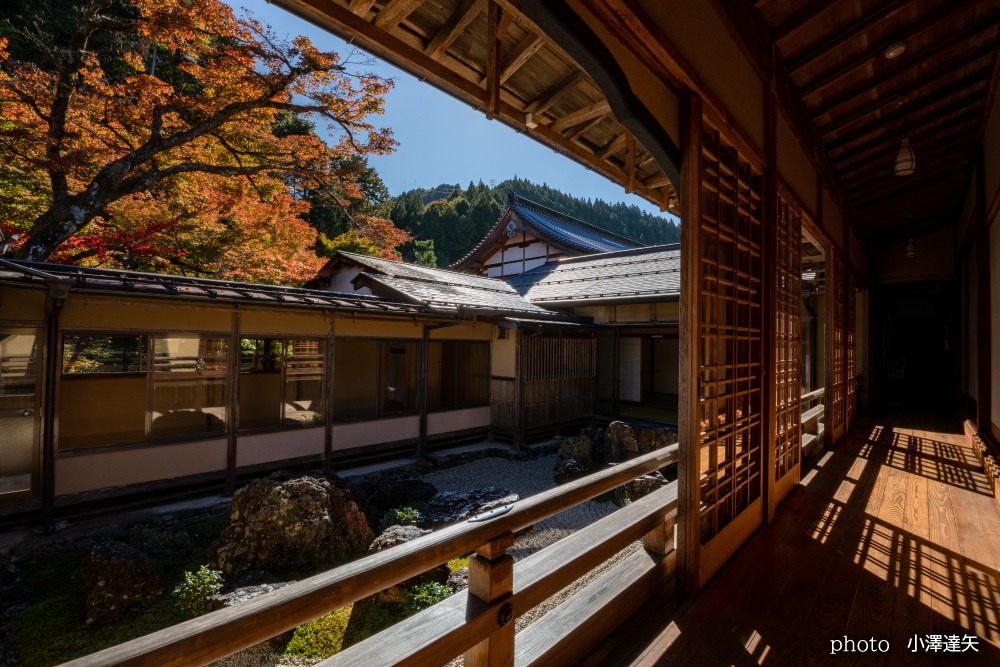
[0,260,423,314]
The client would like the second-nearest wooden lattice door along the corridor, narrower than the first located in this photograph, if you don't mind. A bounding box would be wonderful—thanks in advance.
[770,195,802,507]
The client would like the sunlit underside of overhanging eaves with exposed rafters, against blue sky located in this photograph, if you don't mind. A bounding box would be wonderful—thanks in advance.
[271,0,678,213]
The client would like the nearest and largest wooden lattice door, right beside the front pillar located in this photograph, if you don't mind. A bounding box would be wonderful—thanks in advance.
[690,125,763,582]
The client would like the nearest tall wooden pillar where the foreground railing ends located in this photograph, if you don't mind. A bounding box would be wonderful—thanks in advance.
[677,92,703,593]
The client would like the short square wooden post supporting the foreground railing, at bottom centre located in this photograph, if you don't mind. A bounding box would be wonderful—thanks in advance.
[465,533,514,667]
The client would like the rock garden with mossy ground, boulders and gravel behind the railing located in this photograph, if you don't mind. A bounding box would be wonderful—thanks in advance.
[0,422,676,667]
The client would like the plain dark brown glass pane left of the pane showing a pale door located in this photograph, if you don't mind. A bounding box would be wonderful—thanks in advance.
[332,338,378,422]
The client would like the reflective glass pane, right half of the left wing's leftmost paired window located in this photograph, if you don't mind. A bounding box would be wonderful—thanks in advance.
[151,334,229,438]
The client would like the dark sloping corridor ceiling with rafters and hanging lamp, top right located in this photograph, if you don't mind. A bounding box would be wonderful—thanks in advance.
[753,0,1000,245]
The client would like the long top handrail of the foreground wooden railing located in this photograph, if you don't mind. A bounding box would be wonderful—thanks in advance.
[67,444,678,667]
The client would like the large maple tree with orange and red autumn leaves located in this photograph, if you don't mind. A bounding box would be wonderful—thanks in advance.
[0,0,408,282]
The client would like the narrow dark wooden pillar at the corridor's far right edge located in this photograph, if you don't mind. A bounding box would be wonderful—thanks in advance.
[975,143,994,434]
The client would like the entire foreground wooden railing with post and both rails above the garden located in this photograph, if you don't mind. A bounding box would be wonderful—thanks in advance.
[68,445,677,667]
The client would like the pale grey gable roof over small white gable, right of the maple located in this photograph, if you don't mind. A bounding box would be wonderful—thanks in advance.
[321,251,565,318]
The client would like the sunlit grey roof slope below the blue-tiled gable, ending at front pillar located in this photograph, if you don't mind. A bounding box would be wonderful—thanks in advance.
[507,243,681,305]
